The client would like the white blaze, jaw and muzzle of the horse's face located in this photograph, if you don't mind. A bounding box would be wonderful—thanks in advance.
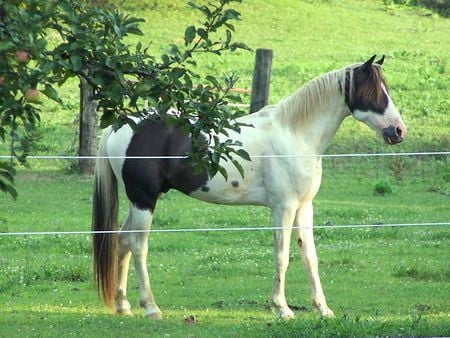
[353,84,407,144]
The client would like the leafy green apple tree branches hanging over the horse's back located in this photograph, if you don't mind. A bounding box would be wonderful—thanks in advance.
[0,0,248,196]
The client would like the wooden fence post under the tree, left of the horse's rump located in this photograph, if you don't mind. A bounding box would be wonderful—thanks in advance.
[78,78,98,175]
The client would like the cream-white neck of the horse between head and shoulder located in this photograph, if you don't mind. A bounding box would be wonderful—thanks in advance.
[278,75,349,154]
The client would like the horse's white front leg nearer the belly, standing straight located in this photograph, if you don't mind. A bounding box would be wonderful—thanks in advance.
[271,208,295,319]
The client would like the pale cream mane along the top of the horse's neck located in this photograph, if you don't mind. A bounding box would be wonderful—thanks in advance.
[276,67,348,128]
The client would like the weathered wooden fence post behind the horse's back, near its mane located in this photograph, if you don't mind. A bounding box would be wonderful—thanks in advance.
[250,48,273,113]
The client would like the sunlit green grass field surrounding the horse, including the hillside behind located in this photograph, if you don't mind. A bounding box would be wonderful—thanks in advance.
[0,0,450,337]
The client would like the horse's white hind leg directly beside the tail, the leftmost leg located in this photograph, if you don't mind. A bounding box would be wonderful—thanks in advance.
[115,213,131,315]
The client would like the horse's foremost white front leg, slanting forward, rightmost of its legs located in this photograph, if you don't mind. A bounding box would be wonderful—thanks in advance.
[294,202,334,318]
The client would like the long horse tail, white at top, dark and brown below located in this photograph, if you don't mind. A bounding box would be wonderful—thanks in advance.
[92,127,119,308]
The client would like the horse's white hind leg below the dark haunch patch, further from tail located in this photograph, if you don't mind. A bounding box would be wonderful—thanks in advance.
[128,207,162,319]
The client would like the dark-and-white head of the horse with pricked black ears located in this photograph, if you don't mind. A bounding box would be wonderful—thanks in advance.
[345,55,407,144]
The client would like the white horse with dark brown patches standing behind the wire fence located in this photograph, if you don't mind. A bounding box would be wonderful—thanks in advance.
[92,55,407,319]
